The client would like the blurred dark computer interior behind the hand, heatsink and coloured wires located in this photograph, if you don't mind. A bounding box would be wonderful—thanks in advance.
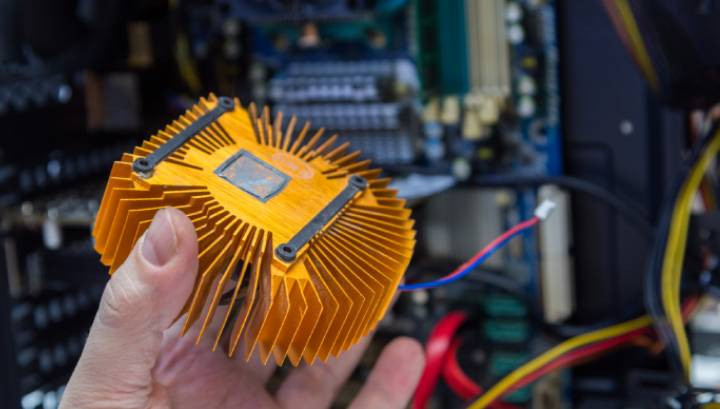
[0,0,720,409]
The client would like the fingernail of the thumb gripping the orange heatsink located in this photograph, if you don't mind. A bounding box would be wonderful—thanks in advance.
[140,209,177,267]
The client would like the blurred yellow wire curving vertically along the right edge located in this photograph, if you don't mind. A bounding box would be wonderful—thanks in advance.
[661,126,720,380]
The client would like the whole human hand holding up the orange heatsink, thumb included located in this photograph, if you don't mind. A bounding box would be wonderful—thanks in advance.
[60,208,424,409]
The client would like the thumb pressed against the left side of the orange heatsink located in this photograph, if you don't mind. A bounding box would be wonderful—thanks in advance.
[61,208,197,408]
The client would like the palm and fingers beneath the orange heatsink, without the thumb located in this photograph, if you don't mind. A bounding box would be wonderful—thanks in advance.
[151,318,417,409]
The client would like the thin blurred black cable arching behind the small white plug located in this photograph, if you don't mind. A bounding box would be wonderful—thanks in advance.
[472,175,654,238]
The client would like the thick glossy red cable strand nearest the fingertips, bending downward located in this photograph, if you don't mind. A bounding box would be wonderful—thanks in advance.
[412,311,467,409]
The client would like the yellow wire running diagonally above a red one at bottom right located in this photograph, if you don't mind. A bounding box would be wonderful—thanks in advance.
[468,315,652,409]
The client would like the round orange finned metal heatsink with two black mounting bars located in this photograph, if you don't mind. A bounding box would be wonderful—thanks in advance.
[93,95,415,365]
